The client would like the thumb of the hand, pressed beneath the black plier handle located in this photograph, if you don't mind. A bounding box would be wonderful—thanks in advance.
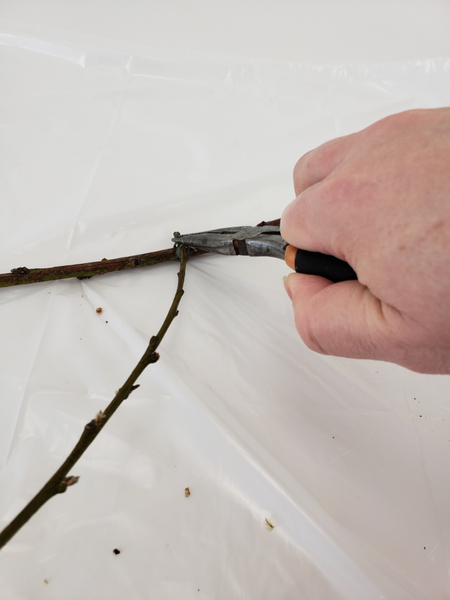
[284,273,402,362]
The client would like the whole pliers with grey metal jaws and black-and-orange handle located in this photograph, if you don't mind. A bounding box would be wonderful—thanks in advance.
[172,225,357,283]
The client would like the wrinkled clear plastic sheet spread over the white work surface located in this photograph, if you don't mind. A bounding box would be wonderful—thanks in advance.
[0,22,450,600]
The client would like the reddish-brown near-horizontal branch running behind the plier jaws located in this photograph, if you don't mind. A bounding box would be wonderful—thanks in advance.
[0,219,280,287]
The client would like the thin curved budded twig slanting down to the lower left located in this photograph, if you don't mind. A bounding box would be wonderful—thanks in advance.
[0,246,187,548]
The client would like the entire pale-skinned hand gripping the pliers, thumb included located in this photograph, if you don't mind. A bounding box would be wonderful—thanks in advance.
[281,108,450,374]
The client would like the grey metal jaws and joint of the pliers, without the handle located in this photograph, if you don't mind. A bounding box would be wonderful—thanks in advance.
[172,225,287,259]
